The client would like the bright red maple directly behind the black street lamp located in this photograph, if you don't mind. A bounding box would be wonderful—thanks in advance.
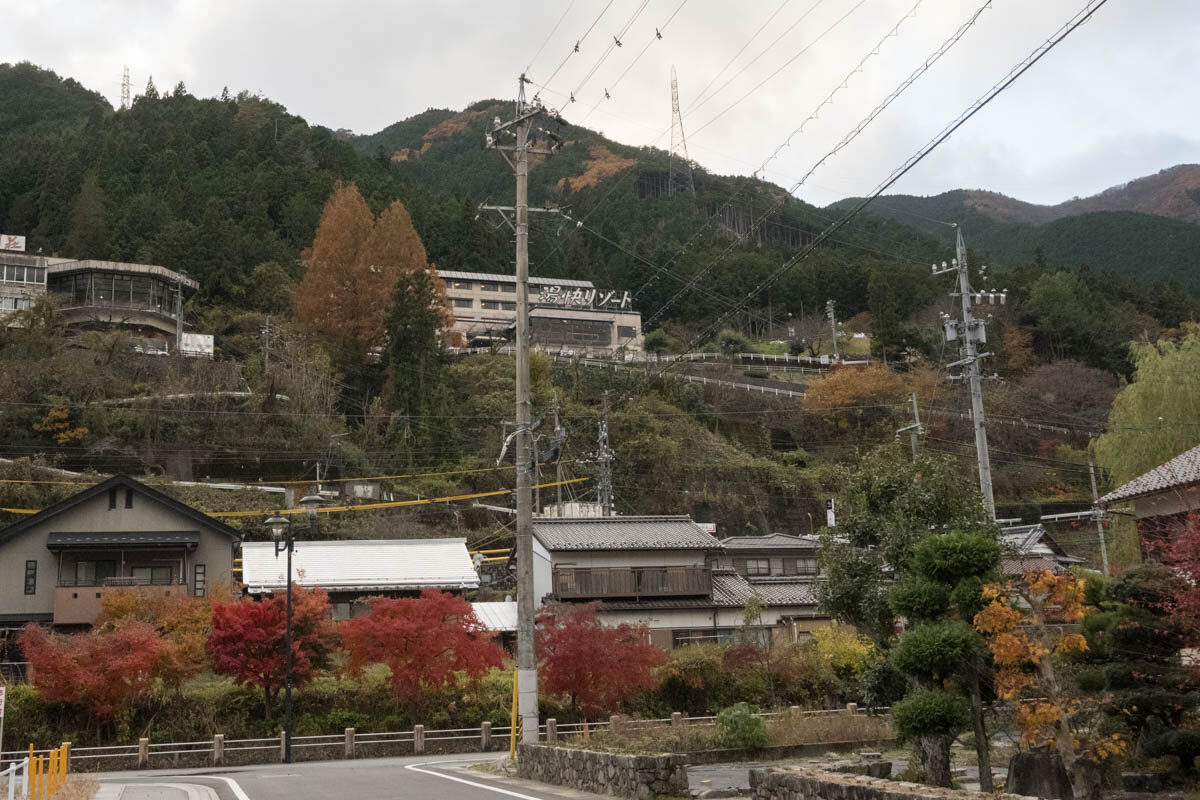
[208,584,337,714]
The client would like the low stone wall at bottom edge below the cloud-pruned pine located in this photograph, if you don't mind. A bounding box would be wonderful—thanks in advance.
[750,768,1032,800]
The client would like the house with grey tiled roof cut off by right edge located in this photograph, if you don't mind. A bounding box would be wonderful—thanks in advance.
[1099,445,1200,558]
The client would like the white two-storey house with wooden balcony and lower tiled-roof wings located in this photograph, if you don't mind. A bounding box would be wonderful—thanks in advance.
[533,517,828,648]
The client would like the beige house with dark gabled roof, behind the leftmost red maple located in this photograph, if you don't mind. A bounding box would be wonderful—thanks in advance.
[0,475,241,628]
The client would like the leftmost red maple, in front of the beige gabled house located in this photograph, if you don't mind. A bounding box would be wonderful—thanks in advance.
[19,622,172,729]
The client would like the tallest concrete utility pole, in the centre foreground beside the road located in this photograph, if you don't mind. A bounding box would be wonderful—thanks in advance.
[486,74,562,744]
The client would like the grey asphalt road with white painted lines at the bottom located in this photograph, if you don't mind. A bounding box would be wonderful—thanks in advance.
[91,753,611,800]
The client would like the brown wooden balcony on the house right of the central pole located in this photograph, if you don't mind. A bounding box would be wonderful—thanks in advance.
[553,566,713,600]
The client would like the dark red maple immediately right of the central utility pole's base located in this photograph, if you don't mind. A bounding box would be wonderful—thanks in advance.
[536,603,667,718]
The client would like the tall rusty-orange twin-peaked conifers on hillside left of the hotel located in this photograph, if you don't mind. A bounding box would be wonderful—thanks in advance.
[296,182,441,361]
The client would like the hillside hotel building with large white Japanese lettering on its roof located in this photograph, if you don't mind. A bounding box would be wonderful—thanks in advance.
[438,270,642,355]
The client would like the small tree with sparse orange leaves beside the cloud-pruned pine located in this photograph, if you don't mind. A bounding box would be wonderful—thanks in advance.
[974,570,1126,798]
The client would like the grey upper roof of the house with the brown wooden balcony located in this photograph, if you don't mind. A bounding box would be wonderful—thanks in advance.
[533,517,721,551]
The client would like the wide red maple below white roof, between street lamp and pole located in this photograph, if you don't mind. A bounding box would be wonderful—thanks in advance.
[338,589,503,700]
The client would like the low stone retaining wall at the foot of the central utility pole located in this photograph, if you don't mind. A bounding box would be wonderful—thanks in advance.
[517,745,688,800]
